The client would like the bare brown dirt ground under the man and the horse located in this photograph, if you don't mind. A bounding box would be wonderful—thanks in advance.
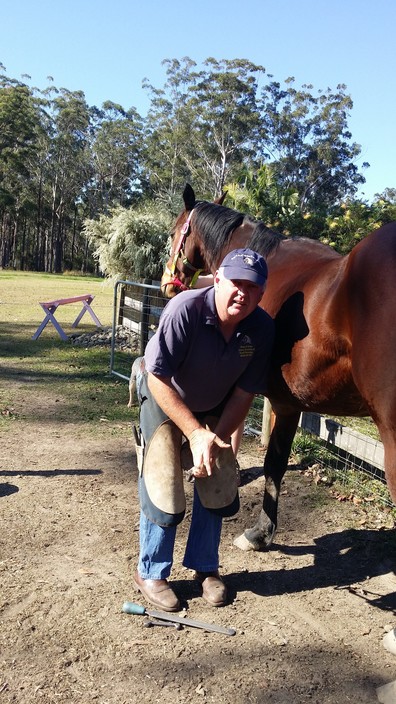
[0,372,396,704]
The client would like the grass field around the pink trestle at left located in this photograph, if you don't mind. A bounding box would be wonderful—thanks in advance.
[0,271,136,433]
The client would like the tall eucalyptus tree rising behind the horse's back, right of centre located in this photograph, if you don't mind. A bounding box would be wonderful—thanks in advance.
[259,78,367,219]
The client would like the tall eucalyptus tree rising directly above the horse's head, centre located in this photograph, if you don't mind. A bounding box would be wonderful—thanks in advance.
[144,57,264,203]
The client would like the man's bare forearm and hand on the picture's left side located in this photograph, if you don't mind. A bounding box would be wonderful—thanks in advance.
[147,373,229,477]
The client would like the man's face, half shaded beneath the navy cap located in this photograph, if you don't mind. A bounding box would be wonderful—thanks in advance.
[214,271,265,324]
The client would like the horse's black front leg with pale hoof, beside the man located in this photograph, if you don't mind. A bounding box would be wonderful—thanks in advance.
[234,413,300,550]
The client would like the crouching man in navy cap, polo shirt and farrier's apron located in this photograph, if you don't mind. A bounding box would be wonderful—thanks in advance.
[134,249,274,611]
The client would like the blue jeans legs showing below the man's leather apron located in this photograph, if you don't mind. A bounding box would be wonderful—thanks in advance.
[138,487,222,579]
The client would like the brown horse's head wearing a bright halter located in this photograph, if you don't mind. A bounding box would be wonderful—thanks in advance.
[161,183,226,298]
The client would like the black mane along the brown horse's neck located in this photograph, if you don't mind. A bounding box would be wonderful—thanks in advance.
[194,201,286,269]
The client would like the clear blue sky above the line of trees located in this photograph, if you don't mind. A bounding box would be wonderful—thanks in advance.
[0,0,396,200]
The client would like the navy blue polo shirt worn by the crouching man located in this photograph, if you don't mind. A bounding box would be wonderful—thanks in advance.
[144,287,274,412]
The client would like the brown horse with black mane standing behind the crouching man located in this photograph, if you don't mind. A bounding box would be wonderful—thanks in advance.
[161,185,396,550]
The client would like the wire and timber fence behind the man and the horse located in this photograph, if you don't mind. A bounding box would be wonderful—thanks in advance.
[110,280,394,507]
